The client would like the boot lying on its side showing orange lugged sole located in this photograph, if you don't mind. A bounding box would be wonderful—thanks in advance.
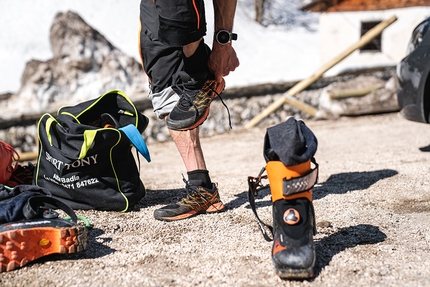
[0,218,89,273]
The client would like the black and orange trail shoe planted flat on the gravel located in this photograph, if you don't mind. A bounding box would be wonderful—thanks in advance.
[154,180,225,221]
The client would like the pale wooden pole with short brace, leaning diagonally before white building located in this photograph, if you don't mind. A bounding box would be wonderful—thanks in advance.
[245,16,397,129]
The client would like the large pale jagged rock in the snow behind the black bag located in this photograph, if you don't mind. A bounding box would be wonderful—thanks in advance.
[0,11,148,120]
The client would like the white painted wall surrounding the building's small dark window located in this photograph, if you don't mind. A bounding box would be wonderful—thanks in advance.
[319,6,430,75]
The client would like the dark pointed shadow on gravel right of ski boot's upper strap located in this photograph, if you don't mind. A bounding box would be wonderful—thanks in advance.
[313,169,398,200]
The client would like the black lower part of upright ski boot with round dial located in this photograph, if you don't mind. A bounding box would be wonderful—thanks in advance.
[272,198,316,279]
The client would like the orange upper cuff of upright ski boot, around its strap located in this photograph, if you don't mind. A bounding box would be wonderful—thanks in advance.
[266,160,312,202]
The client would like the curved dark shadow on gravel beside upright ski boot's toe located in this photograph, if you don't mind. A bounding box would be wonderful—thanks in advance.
[314,224,387,279]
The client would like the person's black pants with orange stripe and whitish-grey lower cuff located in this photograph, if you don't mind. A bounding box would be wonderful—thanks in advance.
[139,0,206,118]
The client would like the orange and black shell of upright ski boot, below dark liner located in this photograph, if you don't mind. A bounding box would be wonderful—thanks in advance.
[266,161,317,279]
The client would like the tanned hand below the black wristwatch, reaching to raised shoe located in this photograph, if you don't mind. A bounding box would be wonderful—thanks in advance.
[208,41,239,83]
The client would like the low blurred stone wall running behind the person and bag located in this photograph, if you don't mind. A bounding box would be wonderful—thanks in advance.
[0,68,398,155]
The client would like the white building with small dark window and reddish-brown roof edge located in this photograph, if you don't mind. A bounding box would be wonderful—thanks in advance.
[302,0,430,72]
